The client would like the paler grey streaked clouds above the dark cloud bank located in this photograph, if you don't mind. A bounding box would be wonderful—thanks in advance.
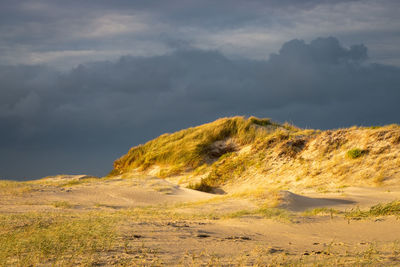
[0,0,400,70]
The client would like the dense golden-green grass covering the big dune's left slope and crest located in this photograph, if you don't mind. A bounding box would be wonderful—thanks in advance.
[111,117,279,174]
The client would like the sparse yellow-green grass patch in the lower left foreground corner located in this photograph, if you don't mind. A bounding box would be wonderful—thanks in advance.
[0,213,116,266]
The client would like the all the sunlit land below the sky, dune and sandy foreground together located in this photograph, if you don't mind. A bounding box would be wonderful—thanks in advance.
[0,117,400,266]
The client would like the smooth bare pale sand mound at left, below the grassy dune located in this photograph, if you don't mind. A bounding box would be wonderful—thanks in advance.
[0,175,213,212]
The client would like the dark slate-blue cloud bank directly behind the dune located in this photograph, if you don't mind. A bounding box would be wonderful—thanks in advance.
[0,37,400,178]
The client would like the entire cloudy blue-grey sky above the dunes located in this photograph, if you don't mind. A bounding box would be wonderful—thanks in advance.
[0,0,400,180]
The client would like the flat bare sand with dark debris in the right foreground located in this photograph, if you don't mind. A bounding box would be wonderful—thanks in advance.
[114,218,400,265]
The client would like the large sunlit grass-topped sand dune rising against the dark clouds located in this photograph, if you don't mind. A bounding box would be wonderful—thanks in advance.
[110,117,400,193]
